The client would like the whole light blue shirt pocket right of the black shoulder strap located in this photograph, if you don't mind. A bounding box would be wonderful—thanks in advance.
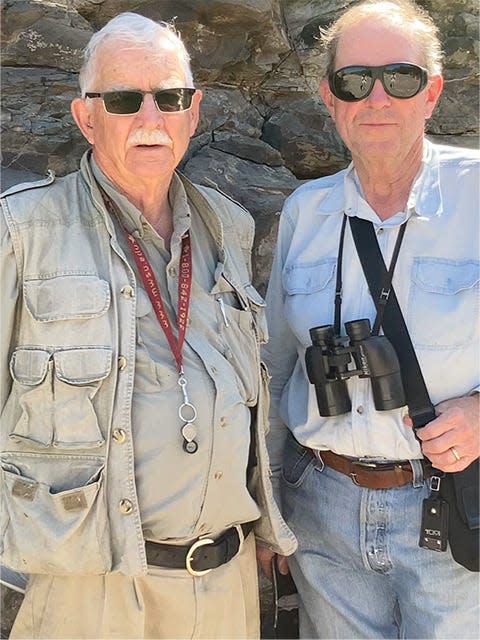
[407,258,480,350]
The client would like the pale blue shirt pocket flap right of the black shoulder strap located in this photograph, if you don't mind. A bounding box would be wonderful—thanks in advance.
[412,258,480,295]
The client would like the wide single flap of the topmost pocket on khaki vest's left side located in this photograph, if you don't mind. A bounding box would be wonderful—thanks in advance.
[24,275,110,322]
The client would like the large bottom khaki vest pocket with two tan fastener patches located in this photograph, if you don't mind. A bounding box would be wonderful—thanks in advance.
[0,454,111,575]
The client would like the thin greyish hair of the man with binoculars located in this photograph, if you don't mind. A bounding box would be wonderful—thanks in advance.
[320,0,442,79]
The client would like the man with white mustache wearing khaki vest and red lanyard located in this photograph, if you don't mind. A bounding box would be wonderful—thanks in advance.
[0,13,296,638]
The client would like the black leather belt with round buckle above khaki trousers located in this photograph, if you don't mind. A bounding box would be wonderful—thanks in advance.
[145,522,253,576]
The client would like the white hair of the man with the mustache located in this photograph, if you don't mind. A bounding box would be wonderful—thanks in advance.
[78,11,193,95]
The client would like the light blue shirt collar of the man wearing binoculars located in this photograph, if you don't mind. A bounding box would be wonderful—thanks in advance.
[318,139,443,226]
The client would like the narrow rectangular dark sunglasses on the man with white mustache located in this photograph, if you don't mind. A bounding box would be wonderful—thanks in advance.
[85,88,195,116]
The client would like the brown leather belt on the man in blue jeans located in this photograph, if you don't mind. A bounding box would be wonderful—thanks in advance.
[314,451,429,489]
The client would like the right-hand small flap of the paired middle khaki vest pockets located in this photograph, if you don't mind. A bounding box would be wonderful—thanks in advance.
[53,347,112,384]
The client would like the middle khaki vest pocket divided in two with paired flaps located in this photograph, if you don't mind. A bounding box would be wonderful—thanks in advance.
[9,347,112,449]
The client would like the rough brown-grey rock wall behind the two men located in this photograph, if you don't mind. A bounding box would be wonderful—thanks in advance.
[1,0,479,637]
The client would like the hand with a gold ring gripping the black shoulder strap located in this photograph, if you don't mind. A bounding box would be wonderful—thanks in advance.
[404,393,480,473]
